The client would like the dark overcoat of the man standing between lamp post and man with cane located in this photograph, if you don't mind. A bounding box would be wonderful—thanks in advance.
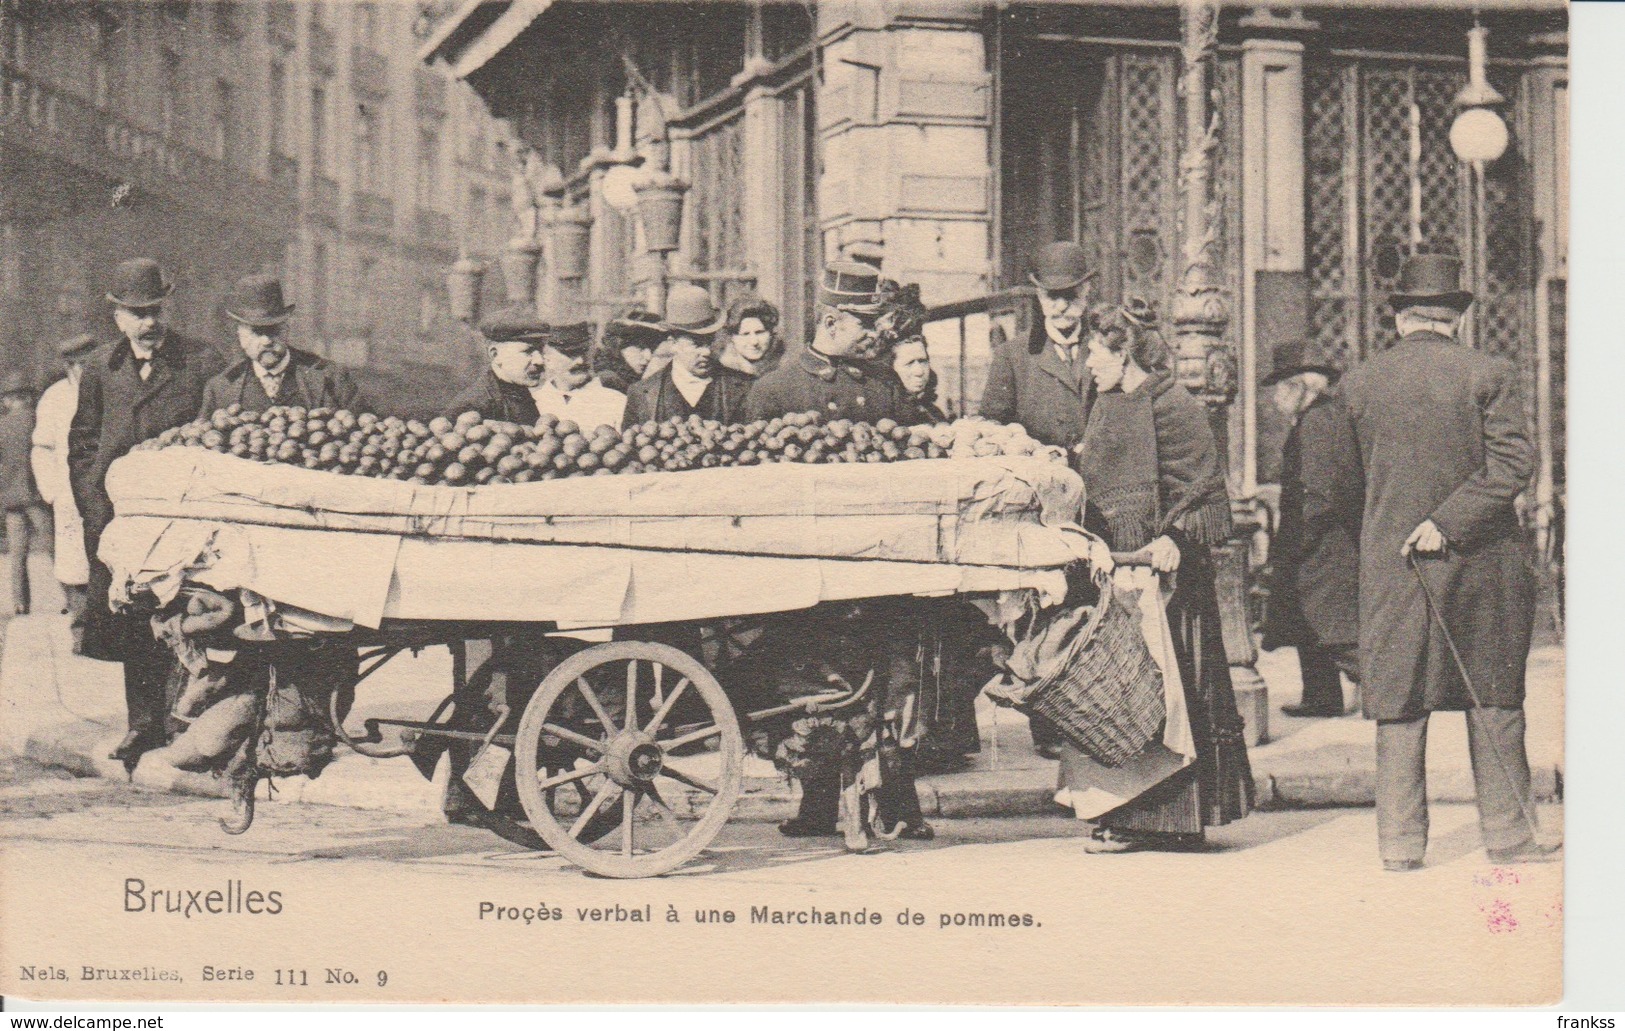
[1264,394,1365,647]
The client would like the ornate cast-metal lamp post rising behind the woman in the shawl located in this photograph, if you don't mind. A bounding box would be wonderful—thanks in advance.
[1172,0,1269,745]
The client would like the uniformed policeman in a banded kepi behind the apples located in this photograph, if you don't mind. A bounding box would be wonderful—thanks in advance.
[743,262,907,423]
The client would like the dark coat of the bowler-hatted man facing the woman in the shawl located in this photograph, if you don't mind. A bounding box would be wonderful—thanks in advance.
[977,305,1095,449]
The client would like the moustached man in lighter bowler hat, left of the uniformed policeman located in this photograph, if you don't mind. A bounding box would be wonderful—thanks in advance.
[622,283,754,426]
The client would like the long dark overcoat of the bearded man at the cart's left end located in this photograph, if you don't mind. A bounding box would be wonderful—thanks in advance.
[68,330,223,660]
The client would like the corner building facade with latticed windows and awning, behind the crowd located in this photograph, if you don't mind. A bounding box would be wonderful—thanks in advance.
[423,0,1568,732]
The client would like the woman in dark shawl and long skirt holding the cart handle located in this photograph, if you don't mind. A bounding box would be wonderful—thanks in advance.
[1061,301,1253,852]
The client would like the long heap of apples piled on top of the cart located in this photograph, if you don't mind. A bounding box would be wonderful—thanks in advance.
[140,405,1064,485]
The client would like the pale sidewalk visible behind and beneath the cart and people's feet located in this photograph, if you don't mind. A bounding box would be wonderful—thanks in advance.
[0,556,1565,820]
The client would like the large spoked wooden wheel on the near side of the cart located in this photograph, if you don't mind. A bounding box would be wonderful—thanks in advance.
[514,641,744,877]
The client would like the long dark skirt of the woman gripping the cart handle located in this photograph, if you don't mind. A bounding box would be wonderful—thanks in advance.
[1061,546,1253,834]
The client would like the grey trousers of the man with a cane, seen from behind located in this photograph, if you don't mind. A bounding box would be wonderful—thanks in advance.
[1376,706,1534,860]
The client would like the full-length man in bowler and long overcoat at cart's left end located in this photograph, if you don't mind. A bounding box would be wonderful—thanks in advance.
[68,259,221,769]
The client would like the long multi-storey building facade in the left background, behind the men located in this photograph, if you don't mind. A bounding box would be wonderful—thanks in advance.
[0,0,512,410]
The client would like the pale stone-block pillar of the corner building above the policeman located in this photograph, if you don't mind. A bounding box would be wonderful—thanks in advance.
[817,0,993,304]
